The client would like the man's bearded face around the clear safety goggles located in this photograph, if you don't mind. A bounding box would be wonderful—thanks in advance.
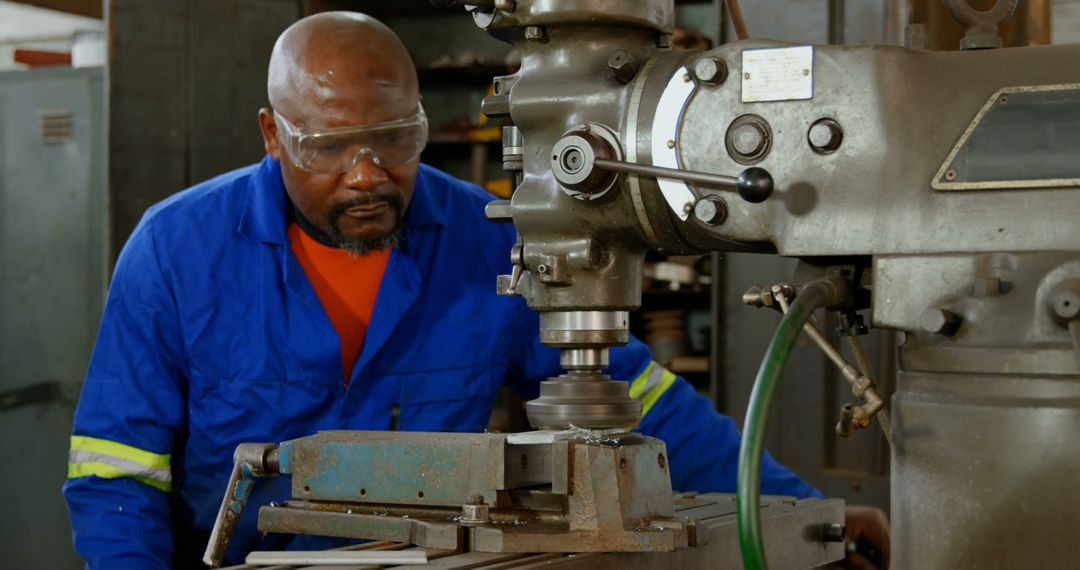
[259,82,419,254]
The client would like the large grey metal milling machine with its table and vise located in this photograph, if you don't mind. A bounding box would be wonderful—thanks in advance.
[207,0,1080,568]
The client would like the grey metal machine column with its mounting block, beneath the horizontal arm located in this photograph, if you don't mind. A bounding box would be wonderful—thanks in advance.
[874,253,1080,568]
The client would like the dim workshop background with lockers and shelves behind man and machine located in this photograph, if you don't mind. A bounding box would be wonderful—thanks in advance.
[0,0,1080,569]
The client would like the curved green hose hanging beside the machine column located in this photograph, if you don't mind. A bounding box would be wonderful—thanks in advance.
[737,282,832,570]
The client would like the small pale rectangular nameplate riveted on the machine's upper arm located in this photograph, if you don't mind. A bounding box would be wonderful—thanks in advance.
[742,45,813,103]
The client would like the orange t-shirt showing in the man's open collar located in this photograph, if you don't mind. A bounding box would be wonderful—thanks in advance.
[288,223,390,385]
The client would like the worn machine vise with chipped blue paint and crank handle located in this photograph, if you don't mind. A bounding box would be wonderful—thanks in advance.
[206,429,690,552]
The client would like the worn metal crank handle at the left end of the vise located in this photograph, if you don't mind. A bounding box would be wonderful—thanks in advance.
[203,444,278,568]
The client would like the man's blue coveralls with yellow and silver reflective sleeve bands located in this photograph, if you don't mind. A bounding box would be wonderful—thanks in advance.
[64,158,816,570]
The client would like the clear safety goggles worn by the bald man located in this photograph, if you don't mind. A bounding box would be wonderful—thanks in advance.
[273,105,428,174]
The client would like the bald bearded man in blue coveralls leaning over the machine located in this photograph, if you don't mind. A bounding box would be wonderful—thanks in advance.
[64,13,885,570]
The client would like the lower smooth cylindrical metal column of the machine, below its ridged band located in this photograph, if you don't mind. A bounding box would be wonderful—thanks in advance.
[892,368,1080,569]
